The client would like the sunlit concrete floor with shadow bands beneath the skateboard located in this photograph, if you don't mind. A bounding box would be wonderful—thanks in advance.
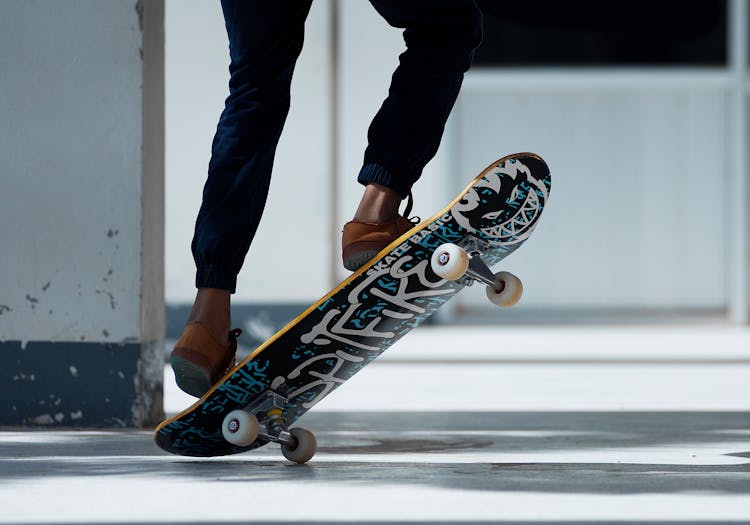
[0,328,750,523]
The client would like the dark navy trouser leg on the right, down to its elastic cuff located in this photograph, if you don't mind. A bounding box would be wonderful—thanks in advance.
[358,0,482,198]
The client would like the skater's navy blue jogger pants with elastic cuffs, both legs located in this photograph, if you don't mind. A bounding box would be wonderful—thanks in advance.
[192,0,481,293]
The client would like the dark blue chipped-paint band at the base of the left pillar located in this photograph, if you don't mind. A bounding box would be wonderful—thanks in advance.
[0,341,164,427]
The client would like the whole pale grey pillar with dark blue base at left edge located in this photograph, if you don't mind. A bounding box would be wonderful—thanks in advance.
[0,0,164,427]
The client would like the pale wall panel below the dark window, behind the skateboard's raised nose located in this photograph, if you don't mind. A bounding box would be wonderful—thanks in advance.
[452,71,731,313]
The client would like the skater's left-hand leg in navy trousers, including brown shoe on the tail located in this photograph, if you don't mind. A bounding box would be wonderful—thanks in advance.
[172,0,311,396]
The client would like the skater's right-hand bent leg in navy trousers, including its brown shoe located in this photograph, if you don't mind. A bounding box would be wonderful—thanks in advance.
[342,0,482,270]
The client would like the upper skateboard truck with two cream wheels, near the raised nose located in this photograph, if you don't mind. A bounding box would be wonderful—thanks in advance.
[430,235,523,306]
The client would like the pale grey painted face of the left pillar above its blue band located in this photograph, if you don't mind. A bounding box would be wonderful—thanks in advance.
[0,0,161,342]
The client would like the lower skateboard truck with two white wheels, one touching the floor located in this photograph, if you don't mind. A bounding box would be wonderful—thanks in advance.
[221,378,317,463]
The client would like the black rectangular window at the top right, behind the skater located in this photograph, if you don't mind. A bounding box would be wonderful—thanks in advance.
[475,0,727,67]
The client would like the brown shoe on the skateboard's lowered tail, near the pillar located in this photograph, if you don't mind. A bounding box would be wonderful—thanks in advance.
[169,321,242,397]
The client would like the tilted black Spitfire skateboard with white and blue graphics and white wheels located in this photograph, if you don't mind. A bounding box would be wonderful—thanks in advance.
[154,153,551,463]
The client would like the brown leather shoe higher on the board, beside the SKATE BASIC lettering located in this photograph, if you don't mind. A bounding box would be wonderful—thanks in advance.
[341,193,419,272]
